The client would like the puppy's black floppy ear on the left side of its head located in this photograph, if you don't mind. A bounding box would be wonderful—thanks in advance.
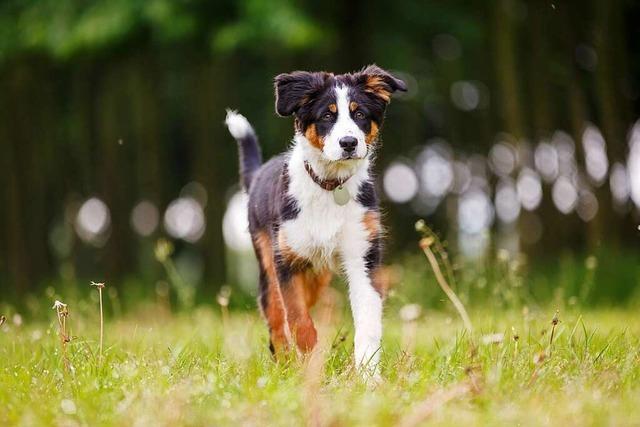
[275,71,329,116]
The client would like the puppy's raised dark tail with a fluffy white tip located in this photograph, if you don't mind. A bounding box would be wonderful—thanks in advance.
[224,110,262,191]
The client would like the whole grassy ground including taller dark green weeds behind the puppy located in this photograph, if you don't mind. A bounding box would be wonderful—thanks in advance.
[0,236,640,427]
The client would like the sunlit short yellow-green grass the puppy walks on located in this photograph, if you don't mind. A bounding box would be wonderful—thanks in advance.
[0,302,640,426]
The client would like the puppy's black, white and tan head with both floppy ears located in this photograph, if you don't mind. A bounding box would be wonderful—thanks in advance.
[275,65,407,162]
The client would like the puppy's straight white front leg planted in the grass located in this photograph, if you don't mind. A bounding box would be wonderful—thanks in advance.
[343,239,382,377]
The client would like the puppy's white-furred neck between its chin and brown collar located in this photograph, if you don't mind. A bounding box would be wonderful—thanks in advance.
[292,132,371,180]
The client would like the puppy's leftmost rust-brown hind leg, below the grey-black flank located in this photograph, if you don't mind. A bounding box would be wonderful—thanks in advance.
[253,231,290,357]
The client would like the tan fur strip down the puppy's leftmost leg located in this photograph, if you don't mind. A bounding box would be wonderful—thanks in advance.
[254,231,289,357]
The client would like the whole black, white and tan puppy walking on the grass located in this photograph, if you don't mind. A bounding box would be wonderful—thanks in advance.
[226,65,406,374]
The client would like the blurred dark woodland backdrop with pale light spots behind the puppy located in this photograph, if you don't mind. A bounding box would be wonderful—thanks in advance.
[0,0,640,304]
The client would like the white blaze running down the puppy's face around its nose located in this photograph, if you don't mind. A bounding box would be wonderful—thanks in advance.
[322,86,367,160]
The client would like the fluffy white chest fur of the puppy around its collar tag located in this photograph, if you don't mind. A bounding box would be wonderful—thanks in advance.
[281,141,369,270]
